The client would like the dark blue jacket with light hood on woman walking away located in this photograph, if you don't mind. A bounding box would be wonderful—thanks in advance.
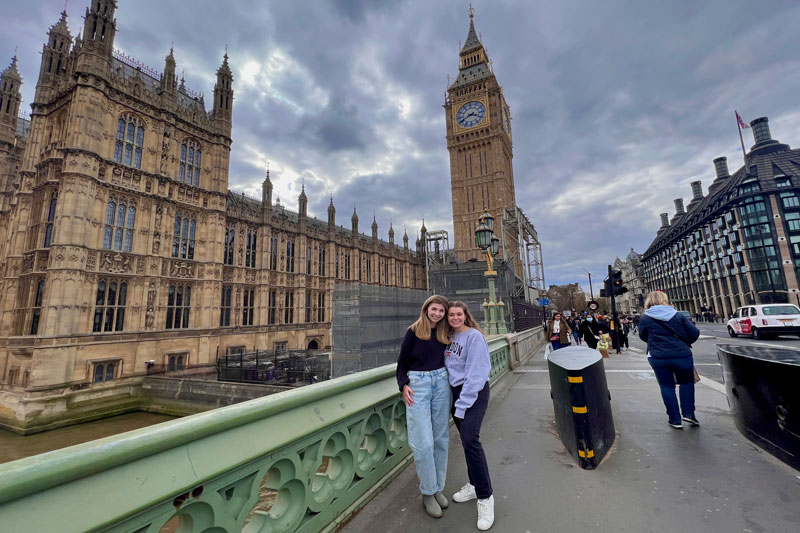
[639,305,700,359]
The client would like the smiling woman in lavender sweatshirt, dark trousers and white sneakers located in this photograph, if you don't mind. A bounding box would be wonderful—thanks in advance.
[444,302,494,531]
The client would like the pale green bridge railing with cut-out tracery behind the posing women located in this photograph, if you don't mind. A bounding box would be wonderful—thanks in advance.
[0,328,540,533]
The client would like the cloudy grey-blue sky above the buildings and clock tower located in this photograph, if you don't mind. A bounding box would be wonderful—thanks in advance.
[0,0,800,289]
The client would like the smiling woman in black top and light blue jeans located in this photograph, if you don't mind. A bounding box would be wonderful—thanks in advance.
[397,294,451,518]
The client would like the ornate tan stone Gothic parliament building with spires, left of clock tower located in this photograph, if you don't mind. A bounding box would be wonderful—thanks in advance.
[0,0,426,432]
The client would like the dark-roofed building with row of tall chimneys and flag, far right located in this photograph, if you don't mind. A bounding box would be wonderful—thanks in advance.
[642,117,800,316]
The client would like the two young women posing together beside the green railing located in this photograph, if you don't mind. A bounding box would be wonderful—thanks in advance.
[397,295,494,531]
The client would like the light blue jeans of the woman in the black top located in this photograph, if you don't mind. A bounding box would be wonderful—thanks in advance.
[406,367,450,496]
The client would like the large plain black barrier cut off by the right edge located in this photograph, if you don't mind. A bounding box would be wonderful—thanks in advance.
[717,344,800,470]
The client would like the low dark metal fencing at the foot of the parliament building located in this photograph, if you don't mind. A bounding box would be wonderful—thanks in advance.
[217,350,331,385]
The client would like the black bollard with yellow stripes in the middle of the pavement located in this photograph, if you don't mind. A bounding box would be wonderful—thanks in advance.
[547,346,615,470]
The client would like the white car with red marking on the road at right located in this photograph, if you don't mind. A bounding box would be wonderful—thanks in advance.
[728,304,800,339]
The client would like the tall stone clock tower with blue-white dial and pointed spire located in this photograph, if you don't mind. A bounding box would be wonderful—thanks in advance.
[444,7,515,257]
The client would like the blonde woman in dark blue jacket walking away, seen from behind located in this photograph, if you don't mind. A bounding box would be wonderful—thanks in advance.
[639,291,700,429]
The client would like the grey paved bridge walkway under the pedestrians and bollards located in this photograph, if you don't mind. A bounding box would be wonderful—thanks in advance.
[344,339,800,533]
